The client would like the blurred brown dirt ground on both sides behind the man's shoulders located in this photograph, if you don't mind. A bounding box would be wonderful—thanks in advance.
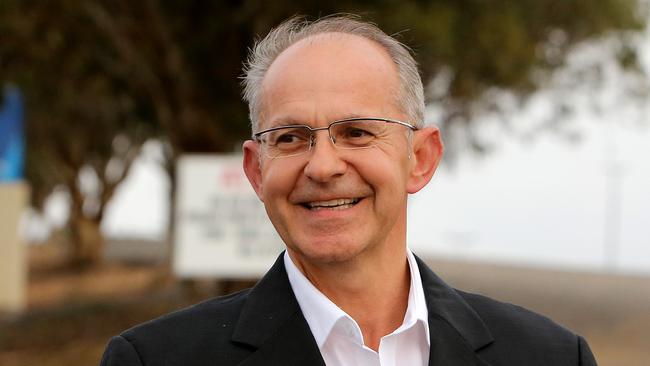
[0,243,650,366]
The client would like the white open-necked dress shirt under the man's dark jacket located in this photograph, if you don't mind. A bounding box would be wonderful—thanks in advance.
[284,250,430,366]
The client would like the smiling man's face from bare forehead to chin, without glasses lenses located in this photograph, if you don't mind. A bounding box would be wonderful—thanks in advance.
[244,34,436,264]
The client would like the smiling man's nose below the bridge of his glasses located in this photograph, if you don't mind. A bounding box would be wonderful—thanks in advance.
[304,130,347,183]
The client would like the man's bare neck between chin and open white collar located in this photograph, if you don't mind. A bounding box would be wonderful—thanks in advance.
[289,245,411,351]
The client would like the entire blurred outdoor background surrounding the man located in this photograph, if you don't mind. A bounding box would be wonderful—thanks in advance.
[0,0,650,366]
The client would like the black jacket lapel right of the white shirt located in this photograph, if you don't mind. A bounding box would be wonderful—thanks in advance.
[416,257,493,366]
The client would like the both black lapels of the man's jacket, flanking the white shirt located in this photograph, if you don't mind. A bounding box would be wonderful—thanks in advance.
[232,254,493,366]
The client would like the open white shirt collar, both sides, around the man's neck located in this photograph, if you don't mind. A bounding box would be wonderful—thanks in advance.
[284,249,431,349]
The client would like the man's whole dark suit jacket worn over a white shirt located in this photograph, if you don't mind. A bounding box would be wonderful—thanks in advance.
[101,256,596,366]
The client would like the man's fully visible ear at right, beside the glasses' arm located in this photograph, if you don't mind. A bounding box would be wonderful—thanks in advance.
[406,127,444,193]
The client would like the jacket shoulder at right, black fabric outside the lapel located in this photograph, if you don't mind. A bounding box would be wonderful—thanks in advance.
[457,290,595,365]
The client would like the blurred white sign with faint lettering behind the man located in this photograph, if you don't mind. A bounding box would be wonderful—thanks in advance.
[173,155,284,278]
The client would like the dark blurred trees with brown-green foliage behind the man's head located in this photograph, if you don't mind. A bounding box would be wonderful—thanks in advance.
[0,0,645,262]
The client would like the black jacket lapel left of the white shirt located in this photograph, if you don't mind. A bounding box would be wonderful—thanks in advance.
[232,254,325,366]
